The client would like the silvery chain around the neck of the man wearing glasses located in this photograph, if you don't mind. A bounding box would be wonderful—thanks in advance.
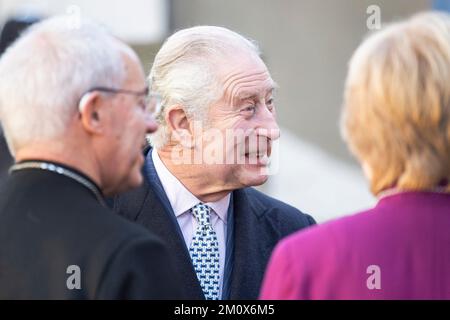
[9,160,106,207]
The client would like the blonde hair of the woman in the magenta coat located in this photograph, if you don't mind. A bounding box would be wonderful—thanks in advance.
[341,12,450,194]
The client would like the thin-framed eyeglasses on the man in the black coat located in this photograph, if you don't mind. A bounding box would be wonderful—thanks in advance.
[79,87,162,116]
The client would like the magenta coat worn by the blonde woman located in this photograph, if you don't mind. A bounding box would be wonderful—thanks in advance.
[260,192,450,299]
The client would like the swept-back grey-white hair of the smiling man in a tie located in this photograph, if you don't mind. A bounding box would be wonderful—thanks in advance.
[149,26,260,149]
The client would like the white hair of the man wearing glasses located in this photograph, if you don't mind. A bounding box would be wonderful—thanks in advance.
[0,16,131,154]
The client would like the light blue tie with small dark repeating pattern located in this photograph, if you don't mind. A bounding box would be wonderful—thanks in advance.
[189,203,220,300]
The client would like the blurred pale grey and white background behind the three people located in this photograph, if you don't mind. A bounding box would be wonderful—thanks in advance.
[0,0,450,222]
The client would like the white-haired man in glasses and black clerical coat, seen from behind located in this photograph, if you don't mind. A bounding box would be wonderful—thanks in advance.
[0,17,183,299]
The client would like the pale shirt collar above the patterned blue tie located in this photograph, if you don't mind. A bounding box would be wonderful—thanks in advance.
[152,148,231,224]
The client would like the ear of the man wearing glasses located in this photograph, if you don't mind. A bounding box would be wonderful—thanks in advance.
[78,92,105,134]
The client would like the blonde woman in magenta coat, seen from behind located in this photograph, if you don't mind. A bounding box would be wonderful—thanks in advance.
[261,13,450,299]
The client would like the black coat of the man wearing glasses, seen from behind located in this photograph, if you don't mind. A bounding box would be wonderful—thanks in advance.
[0,165,180,300]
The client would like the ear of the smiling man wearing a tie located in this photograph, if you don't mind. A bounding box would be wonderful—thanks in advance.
[165,105,193,147]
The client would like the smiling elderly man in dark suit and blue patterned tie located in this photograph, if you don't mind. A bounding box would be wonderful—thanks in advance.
[115,26,314,300]
